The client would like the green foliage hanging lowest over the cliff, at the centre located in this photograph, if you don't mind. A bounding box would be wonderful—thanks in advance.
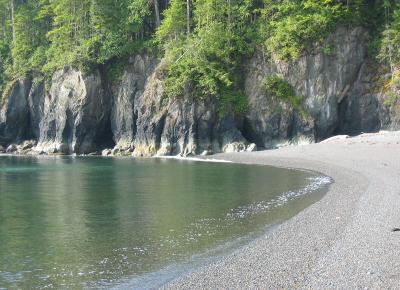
[157,0,252,112]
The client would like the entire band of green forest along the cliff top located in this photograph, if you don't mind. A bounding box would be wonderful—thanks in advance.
[0,0,400,105]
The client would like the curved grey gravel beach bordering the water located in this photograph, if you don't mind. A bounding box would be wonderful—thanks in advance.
[164,132,400,289]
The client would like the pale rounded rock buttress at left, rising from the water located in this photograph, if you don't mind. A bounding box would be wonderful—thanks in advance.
[32,69,111,154]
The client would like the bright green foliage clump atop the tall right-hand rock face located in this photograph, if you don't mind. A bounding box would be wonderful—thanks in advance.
[259,0,350,60]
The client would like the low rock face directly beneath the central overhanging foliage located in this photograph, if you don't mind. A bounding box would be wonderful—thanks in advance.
[158,96,247,156]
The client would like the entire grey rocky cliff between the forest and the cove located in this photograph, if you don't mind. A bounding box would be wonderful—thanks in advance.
[0,28,400,156]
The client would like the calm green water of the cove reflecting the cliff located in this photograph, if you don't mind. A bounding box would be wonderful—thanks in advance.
[0,156,328,289]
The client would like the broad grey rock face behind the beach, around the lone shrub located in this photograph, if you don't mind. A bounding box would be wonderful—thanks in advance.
[245,28,381,148]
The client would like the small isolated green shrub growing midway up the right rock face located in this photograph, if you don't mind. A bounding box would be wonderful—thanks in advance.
[262,75,303,110]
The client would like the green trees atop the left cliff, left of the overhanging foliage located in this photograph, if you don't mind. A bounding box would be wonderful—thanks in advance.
[0,0,154,81]
